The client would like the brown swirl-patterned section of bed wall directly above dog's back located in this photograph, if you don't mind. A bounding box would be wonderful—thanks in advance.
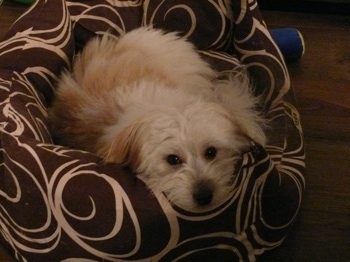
[143,0,232,50]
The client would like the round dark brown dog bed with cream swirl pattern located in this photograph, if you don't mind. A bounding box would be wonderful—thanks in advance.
[0,0,305,261]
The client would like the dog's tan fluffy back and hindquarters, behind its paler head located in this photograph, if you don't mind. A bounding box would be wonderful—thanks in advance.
[49,28,215,152]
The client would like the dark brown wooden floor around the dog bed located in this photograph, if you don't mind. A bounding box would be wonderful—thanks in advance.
[0,1,350,262]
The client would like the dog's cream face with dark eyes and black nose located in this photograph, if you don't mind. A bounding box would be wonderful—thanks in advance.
[106,103,247,211]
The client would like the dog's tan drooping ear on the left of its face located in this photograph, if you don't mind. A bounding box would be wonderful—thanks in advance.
[104,122,143,169]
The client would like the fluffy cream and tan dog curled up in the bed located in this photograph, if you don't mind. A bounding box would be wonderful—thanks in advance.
[48,27,266,212]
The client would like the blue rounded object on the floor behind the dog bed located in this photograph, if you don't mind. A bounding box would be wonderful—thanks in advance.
[270,28,305,63]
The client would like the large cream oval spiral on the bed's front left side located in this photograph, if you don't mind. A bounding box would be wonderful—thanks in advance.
[48,163,141,261]
